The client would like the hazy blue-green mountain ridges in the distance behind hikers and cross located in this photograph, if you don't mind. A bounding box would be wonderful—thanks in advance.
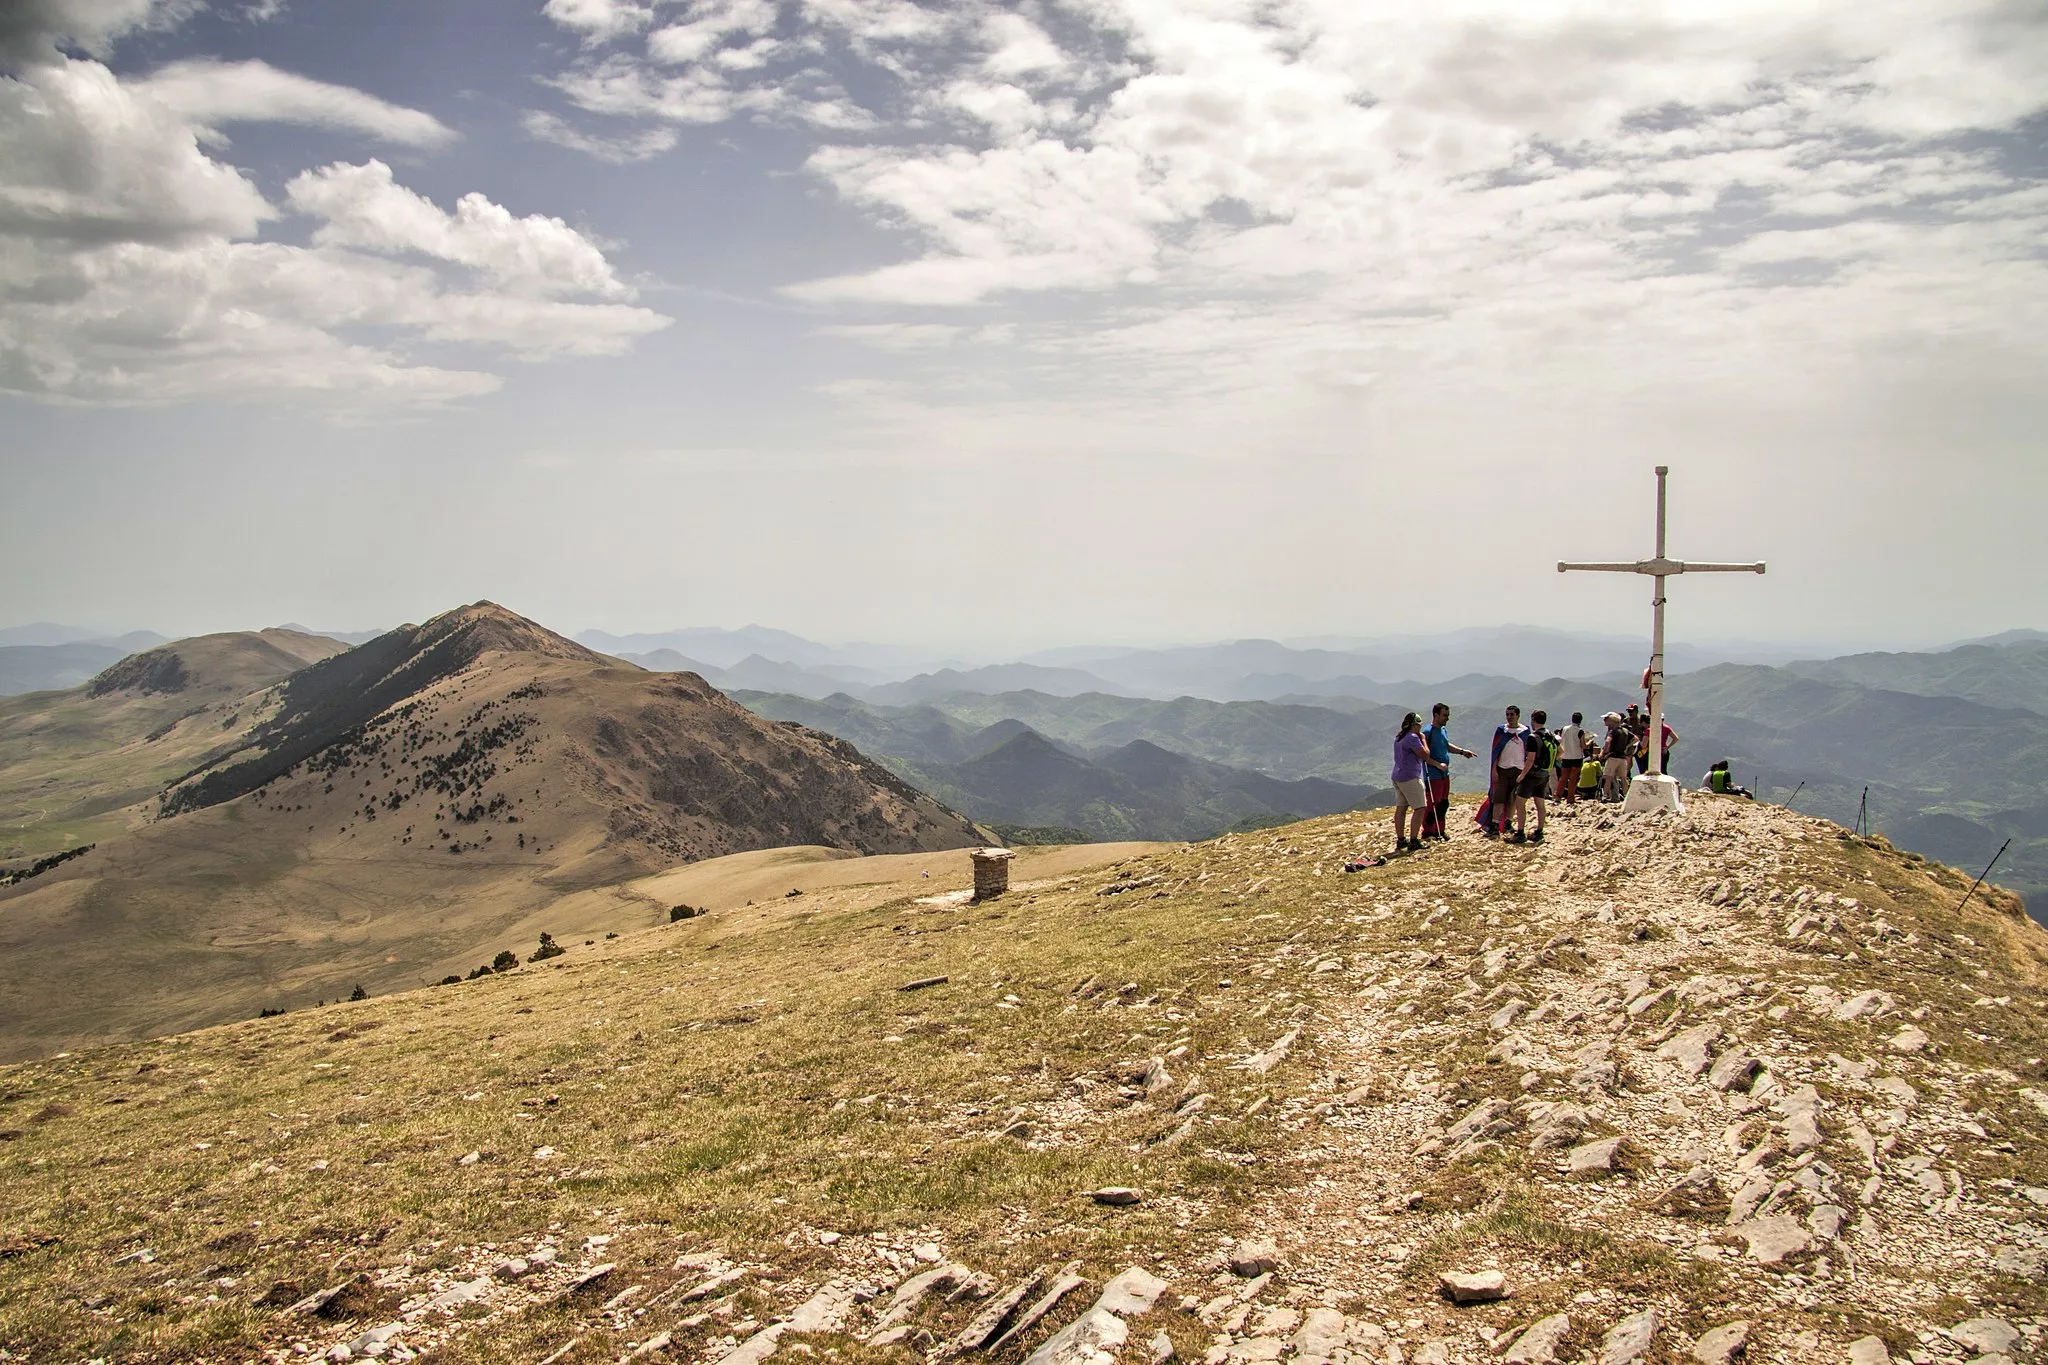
[737,639,2048,909]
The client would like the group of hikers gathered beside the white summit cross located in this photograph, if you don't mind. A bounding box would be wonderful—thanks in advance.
[1393,702,1749,853]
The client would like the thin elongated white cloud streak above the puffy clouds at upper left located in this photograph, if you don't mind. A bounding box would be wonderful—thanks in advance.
[133,59,455,147]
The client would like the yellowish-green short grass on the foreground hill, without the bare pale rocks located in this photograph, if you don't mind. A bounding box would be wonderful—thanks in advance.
[0,817,2048,1363]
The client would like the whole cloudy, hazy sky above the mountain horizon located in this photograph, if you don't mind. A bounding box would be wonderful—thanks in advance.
[0,0,2048,653]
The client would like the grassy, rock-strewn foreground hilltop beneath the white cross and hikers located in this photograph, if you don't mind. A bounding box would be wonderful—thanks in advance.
[0,798,2048,1365]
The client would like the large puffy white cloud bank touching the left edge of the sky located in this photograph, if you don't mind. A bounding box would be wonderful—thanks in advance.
[0,46,670,409]
